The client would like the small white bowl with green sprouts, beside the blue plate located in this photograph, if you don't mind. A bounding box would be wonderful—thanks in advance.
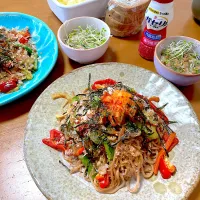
[57,17,110,64]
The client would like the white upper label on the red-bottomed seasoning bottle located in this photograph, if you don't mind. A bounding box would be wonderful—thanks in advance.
[145,1,174,31]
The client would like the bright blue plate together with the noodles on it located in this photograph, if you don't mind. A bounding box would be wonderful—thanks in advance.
[0,12,58,106]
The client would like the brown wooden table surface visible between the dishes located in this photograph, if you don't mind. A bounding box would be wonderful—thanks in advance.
[0,0,200,200]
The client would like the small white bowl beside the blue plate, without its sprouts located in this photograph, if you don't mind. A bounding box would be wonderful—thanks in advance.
[57,17,110,64]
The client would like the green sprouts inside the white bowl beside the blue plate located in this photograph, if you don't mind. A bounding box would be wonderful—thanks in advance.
[65,25,106,49]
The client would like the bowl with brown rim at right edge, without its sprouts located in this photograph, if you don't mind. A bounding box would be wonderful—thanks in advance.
[154,36,200,86]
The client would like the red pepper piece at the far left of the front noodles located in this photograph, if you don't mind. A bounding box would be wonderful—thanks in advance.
[42,129,67,151]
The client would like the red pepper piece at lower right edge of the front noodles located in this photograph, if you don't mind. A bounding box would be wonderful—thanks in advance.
[159,156,176,179]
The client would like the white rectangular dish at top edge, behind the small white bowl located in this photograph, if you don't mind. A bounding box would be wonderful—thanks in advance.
[47,0,109,22]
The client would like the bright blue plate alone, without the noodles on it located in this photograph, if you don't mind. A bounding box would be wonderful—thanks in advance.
[0,12,58,106]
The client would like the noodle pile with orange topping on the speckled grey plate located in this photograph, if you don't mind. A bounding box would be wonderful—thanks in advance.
[43,79,177,193]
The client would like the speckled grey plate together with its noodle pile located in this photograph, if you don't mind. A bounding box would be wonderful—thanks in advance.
[24,63,200,199]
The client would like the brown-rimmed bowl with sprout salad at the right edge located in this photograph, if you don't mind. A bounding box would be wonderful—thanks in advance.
[154,36,200,86]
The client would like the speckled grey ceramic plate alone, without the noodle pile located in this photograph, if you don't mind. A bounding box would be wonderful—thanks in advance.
[24,63,200,200]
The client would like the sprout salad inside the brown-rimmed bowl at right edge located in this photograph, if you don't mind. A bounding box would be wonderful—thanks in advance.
[161,40,200,74]
